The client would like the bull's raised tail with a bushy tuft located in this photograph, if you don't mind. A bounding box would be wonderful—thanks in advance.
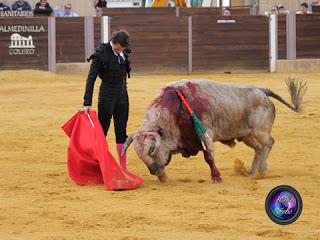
[260,77,307,112]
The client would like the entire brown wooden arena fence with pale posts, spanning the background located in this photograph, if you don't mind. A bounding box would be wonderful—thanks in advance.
[0,8,320,72]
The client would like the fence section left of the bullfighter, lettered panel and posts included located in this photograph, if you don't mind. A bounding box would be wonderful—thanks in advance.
[0,17,109,72]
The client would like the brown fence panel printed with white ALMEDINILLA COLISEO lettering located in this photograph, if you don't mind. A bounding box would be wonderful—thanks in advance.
[0,18,50,70]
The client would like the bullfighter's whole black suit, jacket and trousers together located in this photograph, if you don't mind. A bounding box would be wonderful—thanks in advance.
[83,42,131,143]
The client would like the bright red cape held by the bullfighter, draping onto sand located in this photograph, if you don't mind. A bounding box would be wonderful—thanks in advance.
[62,111,143,190]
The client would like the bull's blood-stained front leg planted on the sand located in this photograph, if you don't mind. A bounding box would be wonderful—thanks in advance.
[203,134,222,183]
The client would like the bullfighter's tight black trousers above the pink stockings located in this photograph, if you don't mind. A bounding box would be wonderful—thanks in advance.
[98,81,129,144]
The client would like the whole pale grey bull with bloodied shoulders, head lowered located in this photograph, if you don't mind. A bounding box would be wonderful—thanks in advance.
[122,79,306,183]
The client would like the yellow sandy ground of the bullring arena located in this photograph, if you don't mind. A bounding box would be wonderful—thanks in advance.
[0,71,320,240]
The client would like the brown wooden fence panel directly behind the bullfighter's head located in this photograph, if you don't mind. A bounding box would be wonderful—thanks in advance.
[111,15,189,72]
